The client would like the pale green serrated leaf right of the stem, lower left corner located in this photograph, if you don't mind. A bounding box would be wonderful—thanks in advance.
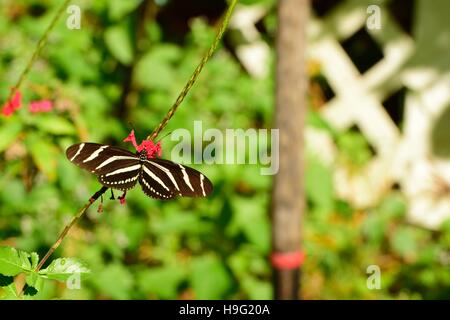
[39,258,90,281]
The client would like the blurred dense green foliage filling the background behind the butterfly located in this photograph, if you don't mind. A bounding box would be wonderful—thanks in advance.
[0,0,450,299]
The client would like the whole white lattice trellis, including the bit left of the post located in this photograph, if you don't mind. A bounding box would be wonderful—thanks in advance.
[231,0,450,229]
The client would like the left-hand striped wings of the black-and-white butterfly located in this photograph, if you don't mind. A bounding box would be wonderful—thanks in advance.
[66,142,142,191]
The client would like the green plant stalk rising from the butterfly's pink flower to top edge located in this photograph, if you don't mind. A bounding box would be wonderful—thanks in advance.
[147,0,237,141]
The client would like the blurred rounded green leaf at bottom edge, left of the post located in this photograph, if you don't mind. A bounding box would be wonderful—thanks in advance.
[190,256,233,299]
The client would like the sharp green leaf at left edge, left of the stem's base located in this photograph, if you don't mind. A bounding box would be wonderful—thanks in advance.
[0,247,31,276]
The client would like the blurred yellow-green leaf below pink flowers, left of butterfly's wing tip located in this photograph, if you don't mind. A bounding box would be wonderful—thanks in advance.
[27,138,58,181]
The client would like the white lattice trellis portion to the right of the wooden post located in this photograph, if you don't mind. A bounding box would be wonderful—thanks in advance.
[308,0,450,228]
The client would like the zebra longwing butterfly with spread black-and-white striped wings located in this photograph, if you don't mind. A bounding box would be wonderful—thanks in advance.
[66,141,213,200]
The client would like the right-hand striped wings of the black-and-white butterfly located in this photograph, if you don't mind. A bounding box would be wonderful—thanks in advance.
[139,158,213,199]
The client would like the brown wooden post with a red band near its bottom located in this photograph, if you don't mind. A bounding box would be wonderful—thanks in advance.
[272,0,309,299]
